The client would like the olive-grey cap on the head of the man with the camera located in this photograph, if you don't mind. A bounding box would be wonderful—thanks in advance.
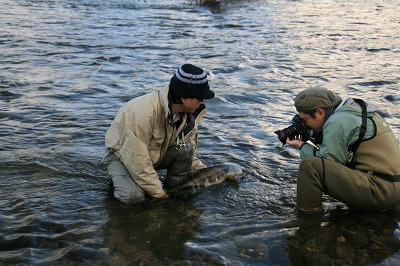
[294,87,342,112]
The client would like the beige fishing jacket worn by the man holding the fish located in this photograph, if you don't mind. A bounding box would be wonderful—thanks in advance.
[105,85,206,198]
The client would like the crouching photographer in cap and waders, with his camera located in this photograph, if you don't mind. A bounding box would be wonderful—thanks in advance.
[275,88,400,214]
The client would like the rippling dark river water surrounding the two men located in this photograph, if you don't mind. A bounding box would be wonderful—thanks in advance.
[0,0,400,265]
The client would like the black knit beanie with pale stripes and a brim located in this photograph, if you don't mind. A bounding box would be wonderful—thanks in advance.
[169,64,215,99]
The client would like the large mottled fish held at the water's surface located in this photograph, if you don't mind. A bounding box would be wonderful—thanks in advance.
[168,164,243,196]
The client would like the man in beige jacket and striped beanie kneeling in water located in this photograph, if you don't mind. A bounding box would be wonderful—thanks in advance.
[103,64,215,203]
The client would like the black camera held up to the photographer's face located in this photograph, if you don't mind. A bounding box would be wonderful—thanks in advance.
[274,114,313,144]
